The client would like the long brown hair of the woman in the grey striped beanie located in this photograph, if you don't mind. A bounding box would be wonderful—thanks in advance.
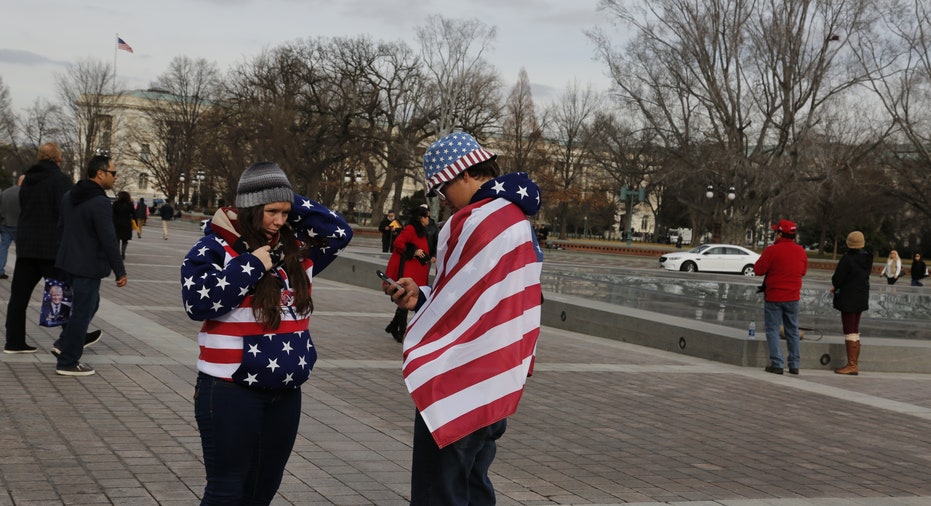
[238,205,314,330]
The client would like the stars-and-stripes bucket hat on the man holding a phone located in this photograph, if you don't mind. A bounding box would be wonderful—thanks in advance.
[423,132,498,197]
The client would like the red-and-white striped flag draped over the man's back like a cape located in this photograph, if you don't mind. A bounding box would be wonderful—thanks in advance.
[403,198,543,448]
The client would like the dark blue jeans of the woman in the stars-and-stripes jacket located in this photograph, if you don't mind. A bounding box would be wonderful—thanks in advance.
[194,373,301,506]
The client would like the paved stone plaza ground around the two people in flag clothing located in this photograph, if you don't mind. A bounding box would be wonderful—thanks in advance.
[0,222,931,506]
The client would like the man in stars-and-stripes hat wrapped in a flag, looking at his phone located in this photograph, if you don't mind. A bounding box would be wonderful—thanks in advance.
[385,132,543,505]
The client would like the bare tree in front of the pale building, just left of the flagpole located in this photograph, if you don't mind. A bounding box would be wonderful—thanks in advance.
[55,59,122,176]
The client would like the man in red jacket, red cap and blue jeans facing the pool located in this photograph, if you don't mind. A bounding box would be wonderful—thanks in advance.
[753,220,808,374]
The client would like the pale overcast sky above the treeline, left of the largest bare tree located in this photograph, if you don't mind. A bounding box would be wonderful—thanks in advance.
[0,0,624,112]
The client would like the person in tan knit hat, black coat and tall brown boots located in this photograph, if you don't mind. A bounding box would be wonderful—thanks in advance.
[831,231,873,376]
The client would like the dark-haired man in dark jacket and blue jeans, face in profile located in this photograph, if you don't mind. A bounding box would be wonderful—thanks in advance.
[53,155,126,376]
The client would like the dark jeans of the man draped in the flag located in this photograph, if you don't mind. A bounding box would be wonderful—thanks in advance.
[411,411,507,506]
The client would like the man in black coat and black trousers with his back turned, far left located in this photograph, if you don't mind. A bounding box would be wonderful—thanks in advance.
[3,142,73,353]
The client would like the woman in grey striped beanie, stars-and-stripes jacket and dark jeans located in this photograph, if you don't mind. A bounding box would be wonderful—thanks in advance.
[181,162,352,505]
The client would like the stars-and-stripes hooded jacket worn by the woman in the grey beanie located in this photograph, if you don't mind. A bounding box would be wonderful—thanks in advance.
[181,194,352,389]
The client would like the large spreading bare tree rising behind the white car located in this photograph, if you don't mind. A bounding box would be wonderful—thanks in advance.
[590,0,870,243]
